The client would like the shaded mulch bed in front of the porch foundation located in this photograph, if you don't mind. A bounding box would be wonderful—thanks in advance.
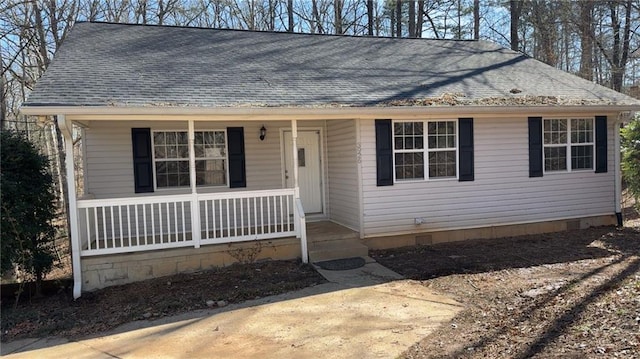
[1,261,326,341]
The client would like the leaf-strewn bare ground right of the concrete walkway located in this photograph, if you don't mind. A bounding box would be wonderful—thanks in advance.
[373,216,640,358]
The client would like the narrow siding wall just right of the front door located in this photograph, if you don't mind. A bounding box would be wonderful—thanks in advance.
[327,121,360,229]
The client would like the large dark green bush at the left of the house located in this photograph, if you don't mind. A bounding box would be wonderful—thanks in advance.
[0,130,56,295]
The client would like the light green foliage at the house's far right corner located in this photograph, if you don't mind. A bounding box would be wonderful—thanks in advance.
[621,116,640,207]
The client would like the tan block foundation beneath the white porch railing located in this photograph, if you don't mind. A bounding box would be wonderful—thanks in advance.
[82,238,300,292]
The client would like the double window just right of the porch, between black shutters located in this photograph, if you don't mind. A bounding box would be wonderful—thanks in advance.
[393,121,458,180]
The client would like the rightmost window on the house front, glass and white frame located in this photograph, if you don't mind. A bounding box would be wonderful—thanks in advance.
[543,118,594,172]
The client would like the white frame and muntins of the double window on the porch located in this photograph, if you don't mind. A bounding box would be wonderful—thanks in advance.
[151,129,229,191]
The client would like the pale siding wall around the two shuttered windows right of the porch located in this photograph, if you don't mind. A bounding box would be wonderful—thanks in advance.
[360,116,615,237]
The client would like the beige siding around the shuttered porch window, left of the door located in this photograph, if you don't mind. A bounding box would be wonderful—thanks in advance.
[85,121,294,198]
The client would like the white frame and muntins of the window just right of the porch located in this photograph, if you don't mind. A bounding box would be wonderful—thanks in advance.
[391,118,460,184]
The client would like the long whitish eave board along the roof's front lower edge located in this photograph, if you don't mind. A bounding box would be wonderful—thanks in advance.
[20,105,640,120]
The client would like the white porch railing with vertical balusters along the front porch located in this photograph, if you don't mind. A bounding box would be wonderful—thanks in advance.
[77,188,306,259]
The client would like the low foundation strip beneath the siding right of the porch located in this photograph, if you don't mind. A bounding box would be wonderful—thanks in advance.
[362,214,617,249]
